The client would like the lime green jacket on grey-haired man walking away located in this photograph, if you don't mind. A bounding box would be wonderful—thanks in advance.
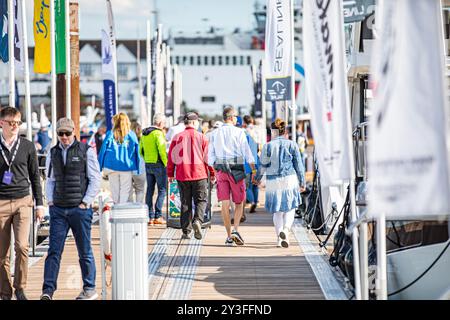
[139,127,167,167]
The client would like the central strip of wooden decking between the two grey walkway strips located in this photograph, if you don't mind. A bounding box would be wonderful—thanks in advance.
[191,209,324,300]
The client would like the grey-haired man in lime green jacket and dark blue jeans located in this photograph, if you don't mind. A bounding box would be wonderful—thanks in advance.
[139,113,167,225]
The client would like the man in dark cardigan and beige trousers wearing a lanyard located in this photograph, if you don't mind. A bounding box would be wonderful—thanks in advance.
[0,107,44,300]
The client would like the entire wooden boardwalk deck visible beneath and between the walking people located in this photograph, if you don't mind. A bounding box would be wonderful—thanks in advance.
[27,198,330,300]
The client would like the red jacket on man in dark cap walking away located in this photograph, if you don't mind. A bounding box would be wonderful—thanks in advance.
[167,127,214,181]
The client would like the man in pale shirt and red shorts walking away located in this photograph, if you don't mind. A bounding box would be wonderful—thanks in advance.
[208,107,256,245]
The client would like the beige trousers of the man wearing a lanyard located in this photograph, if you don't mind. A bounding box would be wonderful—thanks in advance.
[0,195,33,297]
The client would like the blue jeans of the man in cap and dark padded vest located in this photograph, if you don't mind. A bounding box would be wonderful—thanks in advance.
[42,206,96,294]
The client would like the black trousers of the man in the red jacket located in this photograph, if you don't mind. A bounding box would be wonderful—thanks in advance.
[177,179,208,233]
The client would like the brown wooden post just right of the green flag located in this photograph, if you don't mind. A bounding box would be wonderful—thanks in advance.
[70,0,80,138]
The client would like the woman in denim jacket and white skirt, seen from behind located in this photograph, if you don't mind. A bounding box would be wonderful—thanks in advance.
[256,119,305,248]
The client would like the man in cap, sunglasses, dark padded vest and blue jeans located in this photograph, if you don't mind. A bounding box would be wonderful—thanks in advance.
[41,118,102,300]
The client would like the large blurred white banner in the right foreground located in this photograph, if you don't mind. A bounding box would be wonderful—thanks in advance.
[368,0,450,219]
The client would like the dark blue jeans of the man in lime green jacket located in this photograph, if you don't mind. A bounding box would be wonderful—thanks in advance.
[145,163,167,219]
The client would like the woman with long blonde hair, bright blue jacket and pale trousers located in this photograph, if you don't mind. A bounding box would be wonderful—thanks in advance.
[98,112,140,204]
